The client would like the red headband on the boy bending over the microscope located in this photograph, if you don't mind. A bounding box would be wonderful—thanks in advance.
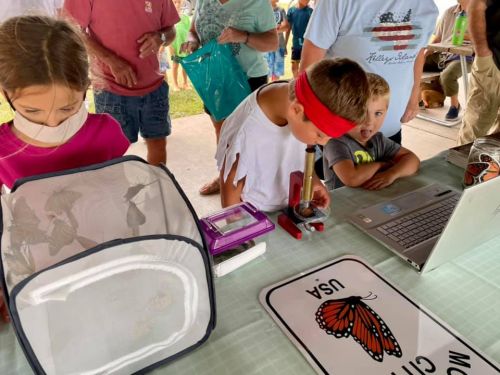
[295,71,356,138]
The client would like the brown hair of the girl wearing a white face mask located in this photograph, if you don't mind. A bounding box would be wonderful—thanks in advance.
[0,16,90,92]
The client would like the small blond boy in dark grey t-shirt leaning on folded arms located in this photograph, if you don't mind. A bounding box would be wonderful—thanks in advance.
[323,73,420,190]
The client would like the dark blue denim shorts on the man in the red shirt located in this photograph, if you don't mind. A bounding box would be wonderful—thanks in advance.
[94,82,171,143]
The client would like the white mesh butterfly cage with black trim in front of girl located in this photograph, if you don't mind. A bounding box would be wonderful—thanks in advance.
[0,156,215,374]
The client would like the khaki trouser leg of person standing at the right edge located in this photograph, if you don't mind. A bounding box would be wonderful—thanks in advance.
[458,56,500,145]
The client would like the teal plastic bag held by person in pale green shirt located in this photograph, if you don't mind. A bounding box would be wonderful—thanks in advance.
[181,40,250,121]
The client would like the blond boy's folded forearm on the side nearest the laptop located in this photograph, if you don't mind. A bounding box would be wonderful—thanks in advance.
[363,147,420,190]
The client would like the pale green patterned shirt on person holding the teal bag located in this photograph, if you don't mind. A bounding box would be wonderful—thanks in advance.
[195,0,276,77]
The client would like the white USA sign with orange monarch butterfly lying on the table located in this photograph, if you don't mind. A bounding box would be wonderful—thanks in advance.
[260,256,500,375]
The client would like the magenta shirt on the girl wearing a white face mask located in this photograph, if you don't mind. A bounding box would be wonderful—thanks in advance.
[0,114,130,188]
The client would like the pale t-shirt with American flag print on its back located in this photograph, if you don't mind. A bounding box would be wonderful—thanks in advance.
[305,0,438,137]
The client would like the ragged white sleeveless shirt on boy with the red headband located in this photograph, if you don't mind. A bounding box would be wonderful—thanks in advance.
[215,91,306,211]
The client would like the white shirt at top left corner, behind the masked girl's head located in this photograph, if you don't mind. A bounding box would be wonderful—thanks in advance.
[0,0,64,22]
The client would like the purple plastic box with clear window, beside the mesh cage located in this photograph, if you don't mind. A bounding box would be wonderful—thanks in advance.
[200,202,274,255]
